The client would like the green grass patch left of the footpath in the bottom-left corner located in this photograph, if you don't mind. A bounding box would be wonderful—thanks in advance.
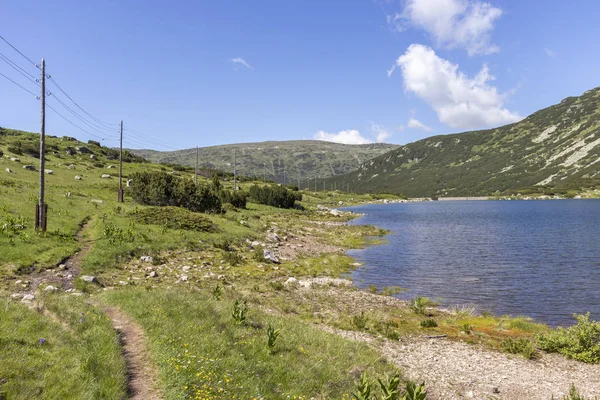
[0,295,126,400]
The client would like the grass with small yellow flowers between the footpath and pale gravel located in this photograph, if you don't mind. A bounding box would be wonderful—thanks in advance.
[102,289,391,399]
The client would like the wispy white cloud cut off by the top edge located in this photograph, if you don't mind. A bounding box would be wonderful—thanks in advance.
[387,0,502,55]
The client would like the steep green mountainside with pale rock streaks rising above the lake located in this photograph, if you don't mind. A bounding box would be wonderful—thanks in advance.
[328,88,600,197]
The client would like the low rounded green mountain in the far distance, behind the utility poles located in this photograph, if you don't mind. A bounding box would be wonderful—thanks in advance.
[129,140,398,183]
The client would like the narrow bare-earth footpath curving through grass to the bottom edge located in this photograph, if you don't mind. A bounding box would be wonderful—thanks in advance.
[103,307,161,400]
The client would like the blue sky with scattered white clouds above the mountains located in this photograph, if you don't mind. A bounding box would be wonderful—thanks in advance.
[0,0,600,150]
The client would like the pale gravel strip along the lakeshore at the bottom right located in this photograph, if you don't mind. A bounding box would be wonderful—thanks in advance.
[326,329,600,400]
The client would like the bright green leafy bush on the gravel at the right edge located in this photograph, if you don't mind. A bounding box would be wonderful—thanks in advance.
[537,313,600,364]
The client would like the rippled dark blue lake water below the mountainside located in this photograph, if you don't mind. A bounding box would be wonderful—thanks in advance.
[346,200,600,326]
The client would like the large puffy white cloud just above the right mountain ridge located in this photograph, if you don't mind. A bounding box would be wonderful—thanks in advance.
[395,44,522,129]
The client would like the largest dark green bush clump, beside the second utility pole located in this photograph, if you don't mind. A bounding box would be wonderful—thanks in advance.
[130,172,221,213]
